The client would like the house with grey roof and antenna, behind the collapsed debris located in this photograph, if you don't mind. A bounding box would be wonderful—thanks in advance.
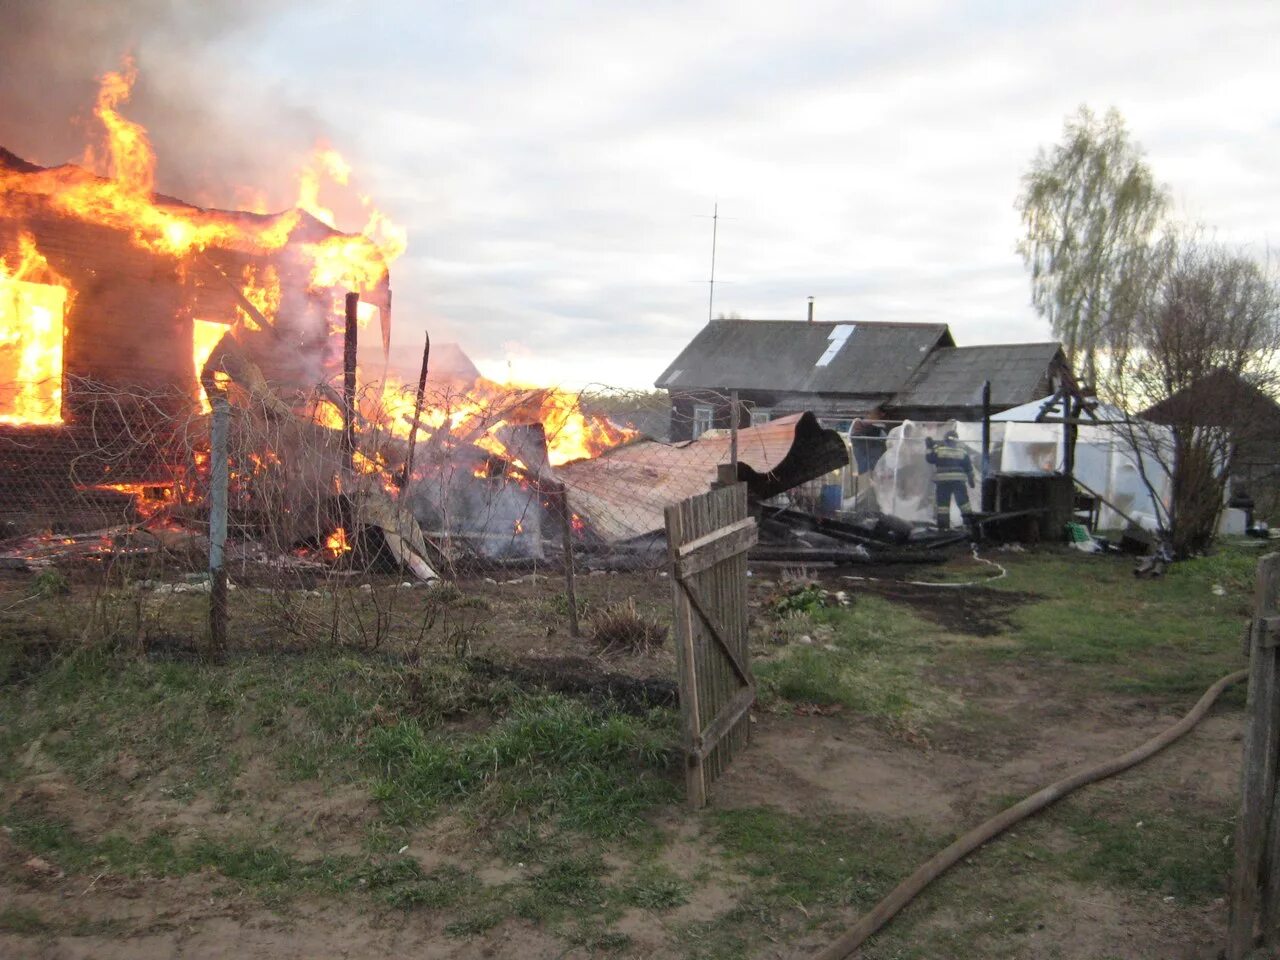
[654,320,1069,440]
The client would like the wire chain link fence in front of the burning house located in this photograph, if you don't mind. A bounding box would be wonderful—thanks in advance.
[0,378,788,649]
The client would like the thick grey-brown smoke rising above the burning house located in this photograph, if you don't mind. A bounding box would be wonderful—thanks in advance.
[0,0,323,207]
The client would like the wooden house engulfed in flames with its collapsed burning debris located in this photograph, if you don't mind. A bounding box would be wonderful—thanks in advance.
[0,64,640,576]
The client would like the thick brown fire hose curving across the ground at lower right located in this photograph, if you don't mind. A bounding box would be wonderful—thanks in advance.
[812,669,1249,960]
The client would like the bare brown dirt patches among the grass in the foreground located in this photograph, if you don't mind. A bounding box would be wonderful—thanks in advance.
[0,560,1242,960]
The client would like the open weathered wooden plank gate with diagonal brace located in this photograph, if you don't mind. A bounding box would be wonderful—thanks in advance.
[666,483,756,809]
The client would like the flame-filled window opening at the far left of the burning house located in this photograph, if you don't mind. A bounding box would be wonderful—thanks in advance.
[0,236,67,425]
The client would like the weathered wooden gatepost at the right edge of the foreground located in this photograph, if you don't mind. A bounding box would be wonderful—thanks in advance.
[1226,553,1280,960]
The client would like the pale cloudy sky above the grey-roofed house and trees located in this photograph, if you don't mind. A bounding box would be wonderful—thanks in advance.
[10,0,1280,387]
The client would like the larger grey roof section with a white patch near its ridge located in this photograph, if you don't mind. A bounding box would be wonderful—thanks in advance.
[655,320,955,394]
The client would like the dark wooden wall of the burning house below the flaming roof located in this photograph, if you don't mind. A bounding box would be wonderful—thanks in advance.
[0,151,390,529]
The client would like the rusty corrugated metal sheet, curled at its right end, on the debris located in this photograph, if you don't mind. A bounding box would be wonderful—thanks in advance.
[556,413,849,543]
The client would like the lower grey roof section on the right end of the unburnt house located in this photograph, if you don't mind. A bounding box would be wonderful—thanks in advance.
[891,343,1061,407]
